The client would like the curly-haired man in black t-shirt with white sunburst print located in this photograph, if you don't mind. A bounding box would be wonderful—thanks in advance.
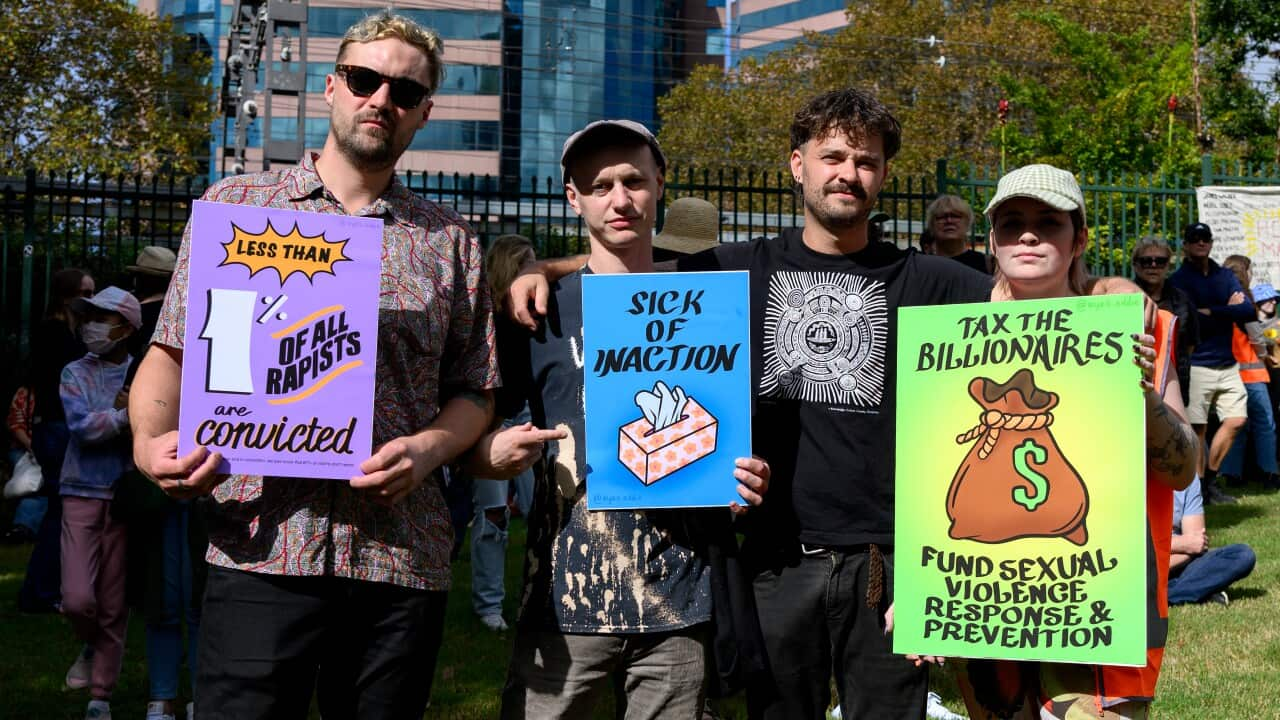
[512,90,991,720]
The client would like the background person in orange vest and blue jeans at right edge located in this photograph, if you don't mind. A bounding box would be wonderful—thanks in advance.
[1220,255,1280,488]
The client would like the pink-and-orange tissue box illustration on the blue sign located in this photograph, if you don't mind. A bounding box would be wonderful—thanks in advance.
[618,382,719,486]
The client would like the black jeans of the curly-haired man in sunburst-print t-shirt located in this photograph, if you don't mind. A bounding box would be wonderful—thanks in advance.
[750,548,929,720]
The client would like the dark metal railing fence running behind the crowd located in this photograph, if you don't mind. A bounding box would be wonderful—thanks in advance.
[0,158,1280,375]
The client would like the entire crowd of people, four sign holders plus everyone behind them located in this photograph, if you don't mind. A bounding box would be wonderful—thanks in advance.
[9,14,1280,720]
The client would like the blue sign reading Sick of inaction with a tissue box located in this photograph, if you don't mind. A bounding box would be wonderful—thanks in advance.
[582,273,751,510]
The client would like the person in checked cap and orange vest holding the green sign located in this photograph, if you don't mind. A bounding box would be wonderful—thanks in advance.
[961,165,1197,720]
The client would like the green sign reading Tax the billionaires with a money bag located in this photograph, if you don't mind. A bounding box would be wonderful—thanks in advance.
[893,295,1147,665]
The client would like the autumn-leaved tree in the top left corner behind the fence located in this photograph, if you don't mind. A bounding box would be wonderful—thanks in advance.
[0,0,215,176]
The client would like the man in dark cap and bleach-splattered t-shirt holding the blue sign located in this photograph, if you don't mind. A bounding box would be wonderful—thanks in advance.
[471,120,768,719]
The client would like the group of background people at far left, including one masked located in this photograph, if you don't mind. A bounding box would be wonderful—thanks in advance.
[5,246,205,719]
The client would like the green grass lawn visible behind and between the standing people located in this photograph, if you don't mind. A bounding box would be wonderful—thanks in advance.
[0,479,1280,720]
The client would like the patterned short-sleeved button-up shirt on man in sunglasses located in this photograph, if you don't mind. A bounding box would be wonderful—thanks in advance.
[152,154,498,589]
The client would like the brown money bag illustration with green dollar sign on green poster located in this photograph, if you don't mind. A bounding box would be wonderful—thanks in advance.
[947,368,1089,544]
